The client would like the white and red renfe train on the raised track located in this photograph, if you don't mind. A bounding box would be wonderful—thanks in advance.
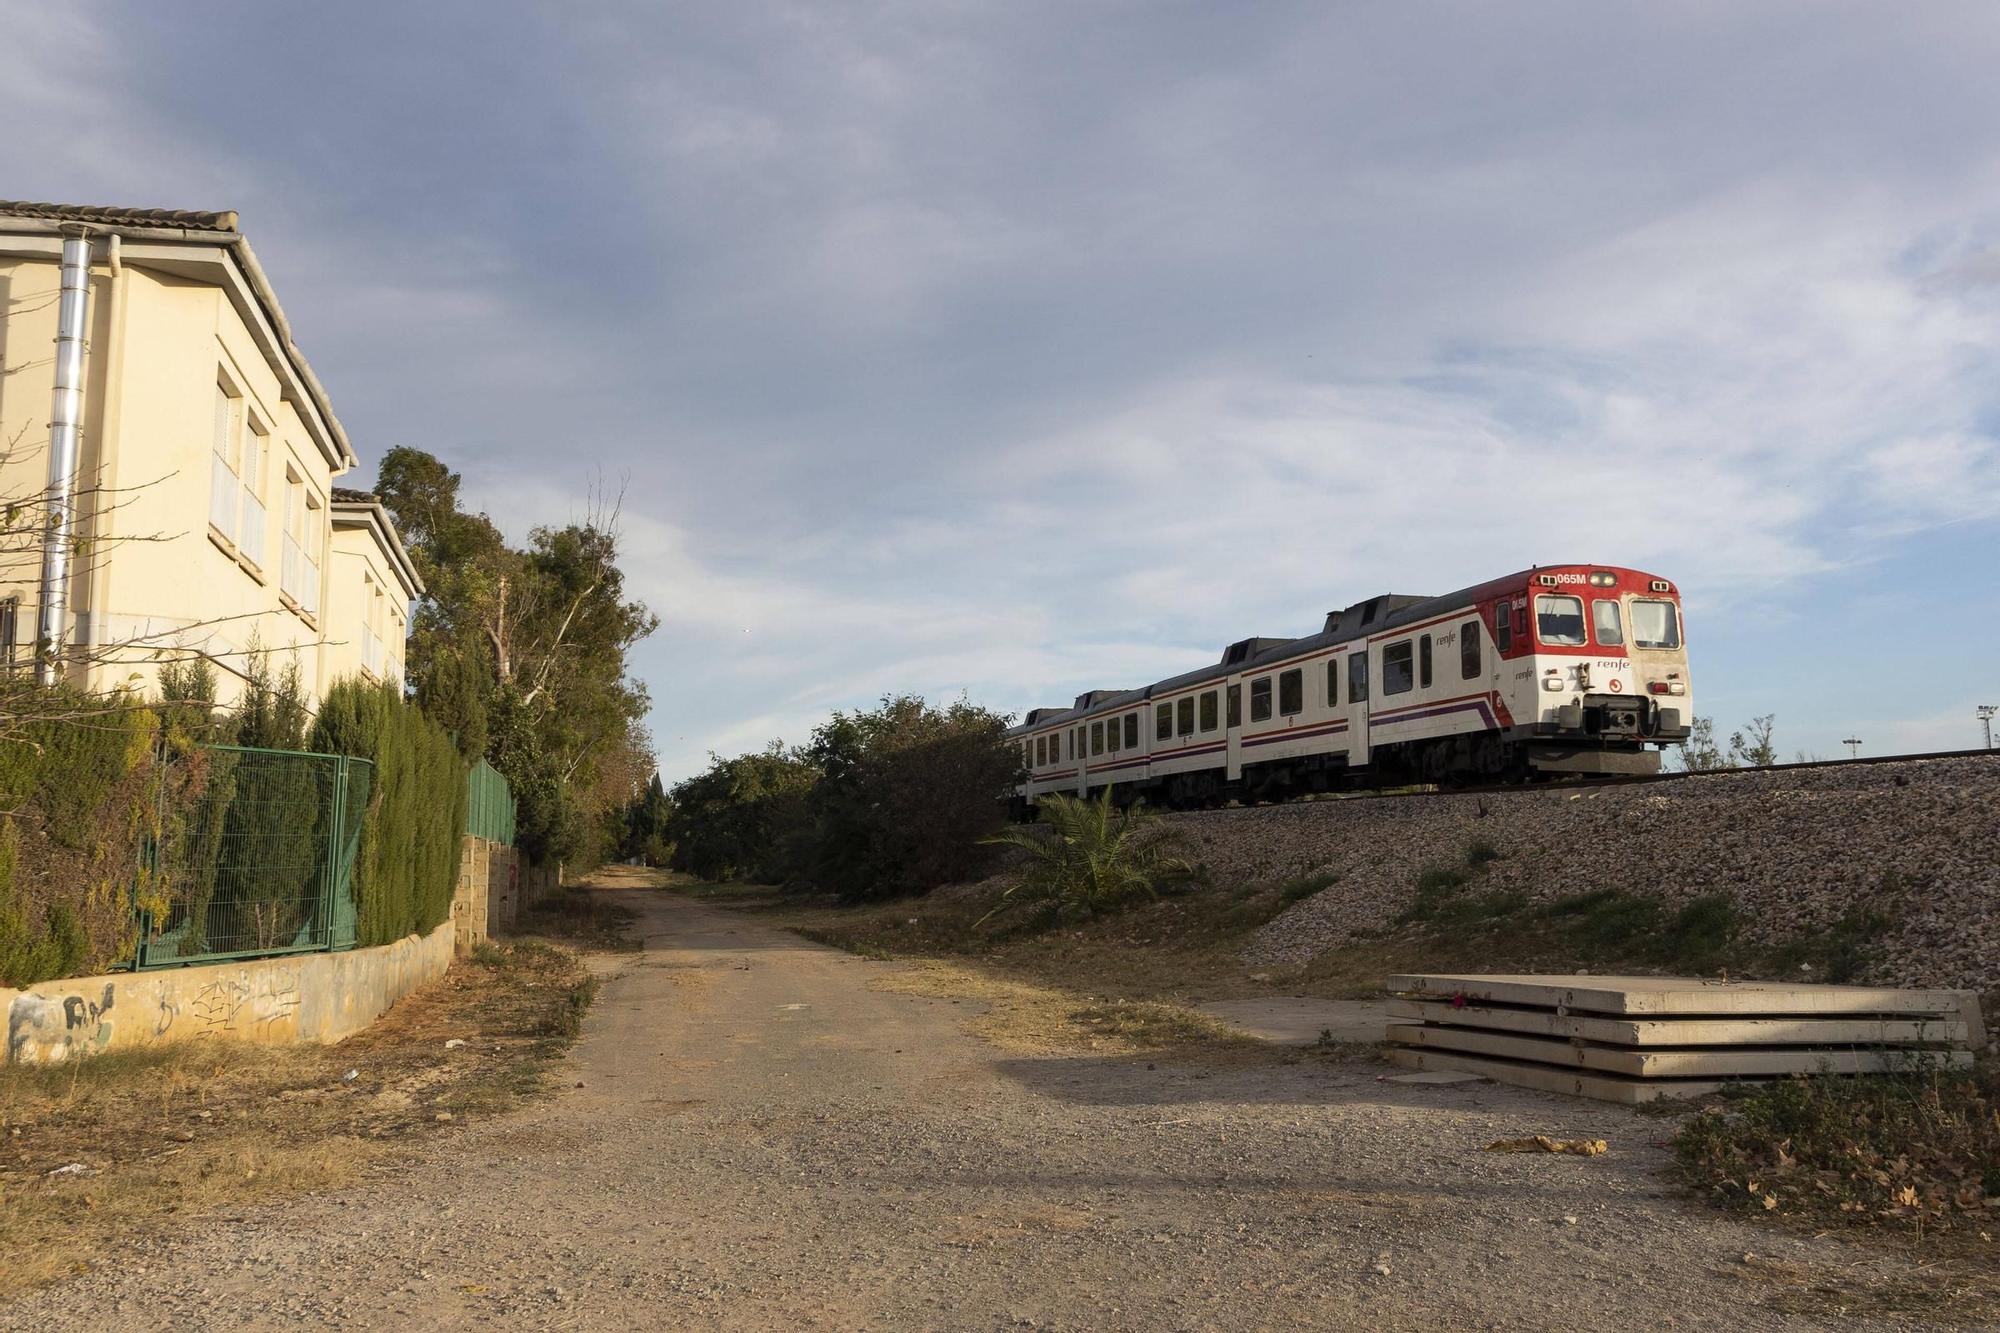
[1008,564,1694,815]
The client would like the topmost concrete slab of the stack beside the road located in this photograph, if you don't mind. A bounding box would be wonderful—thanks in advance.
[1386,973,1970,1017]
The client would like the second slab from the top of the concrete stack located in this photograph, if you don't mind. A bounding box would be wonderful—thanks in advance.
[1388,999,1972,1047]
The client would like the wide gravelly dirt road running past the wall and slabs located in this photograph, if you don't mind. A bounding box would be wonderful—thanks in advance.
[0,880,1968,1333]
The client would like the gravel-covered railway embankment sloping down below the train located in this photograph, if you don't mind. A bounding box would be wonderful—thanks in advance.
[1232,755,2000,993]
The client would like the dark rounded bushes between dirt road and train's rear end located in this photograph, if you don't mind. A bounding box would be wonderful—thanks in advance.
[668,695,1020,901]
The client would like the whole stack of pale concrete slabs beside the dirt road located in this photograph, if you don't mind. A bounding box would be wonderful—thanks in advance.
[1388,973,1986,1103]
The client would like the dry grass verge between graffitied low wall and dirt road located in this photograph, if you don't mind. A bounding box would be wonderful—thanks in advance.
[0,943,594,1299]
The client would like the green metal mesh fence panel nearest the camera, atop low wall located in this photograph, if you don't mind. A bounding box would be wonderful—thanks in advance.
[134,745,374,967]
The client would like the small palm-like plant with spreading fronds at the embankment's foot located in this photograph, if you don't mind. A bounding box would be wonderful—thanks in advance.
[986,787,1194,923]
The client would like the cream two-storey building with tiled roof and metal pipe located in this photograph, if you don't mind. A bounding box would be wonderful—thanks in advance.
[0,202,422,699]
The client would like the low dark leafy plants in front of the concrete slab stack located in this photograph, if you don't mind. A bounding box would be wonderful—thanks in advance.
[1674,1061,2000,1233]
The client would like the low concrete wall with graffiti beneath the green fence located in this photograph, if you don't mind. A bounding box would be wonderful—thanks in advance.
[0,923,452,1065]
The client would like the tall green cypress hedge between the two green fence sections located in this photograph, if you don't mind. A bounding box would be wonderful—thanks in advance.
[310,681,466,945]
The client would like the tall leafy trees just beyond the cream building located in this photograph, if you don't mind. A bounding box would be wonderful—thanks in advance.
[376,448,658,863]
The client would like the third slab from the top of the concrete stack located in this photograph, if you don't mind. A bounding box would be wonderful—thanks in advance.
[1388,1025,1972,1079]
